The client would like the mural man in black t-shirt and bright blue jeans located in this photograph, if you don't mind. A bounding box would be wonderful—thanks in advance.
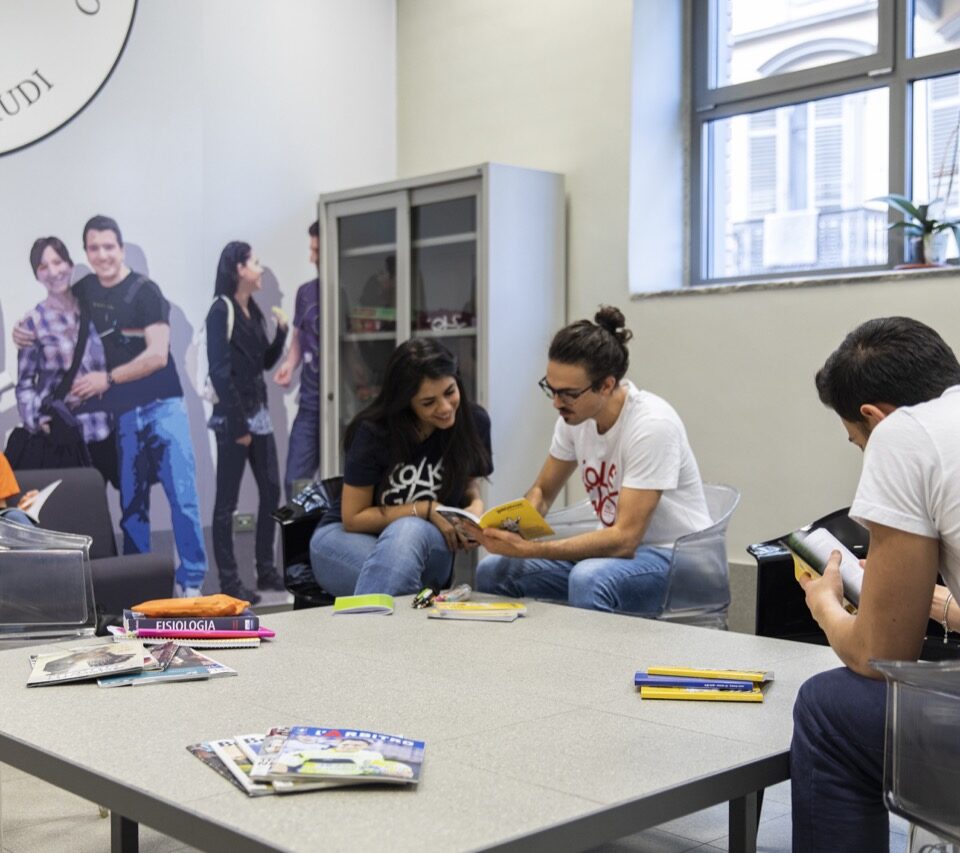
[72,216,207,596]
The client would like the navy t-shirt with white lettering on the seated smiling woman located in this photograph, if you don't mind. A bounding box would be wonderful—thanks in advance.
[323,406,493,524]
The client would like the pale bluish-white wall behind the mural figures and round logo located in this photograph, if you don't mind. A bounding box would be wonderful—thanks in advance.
[0,0,396,529]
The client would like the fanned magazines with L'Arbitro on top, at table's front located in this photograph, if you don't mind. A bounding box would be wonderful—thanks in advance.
[187,726,424,797]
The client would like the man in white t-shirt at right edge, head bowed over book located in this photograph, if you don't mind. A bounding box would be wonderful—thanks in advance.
[790,317,960,853]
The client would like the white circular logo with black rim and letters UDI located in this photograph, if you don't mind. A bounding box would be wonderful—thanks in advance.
[0,0,137,155]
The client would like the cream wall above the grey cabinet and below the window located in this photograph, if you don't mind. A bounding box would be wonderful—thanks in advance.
[397,0,960,561]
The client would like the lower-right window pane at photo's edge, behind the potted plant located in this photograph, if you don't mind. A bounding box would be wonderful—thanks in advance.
[907,74,960,258]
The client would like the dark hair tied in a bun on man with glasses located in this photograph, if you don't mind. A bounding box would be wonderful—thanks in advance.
[547,305,633,384]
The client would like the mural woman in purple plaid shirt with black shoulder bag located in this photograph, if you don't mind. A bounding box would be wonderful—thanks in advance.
[8,237,118,486]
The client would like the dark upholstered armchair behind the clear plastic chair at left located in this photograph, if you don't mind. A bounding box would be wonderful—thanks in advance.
[9,468,174,615]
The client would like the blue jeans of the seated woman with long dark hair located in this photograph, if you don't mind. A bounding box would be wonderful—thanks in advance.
[310,516,453,595]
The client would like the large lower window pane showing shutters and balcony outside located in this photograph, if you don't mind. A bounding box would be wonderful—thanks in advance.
[704,89,889,278]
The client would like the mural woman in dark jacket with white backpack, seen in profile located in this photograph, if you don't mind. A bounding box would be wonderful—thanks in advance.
[206,241,287,604]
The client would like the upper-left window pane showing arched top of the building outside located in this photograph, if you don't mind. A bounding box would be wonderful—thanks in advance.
[710,0,879,87]
